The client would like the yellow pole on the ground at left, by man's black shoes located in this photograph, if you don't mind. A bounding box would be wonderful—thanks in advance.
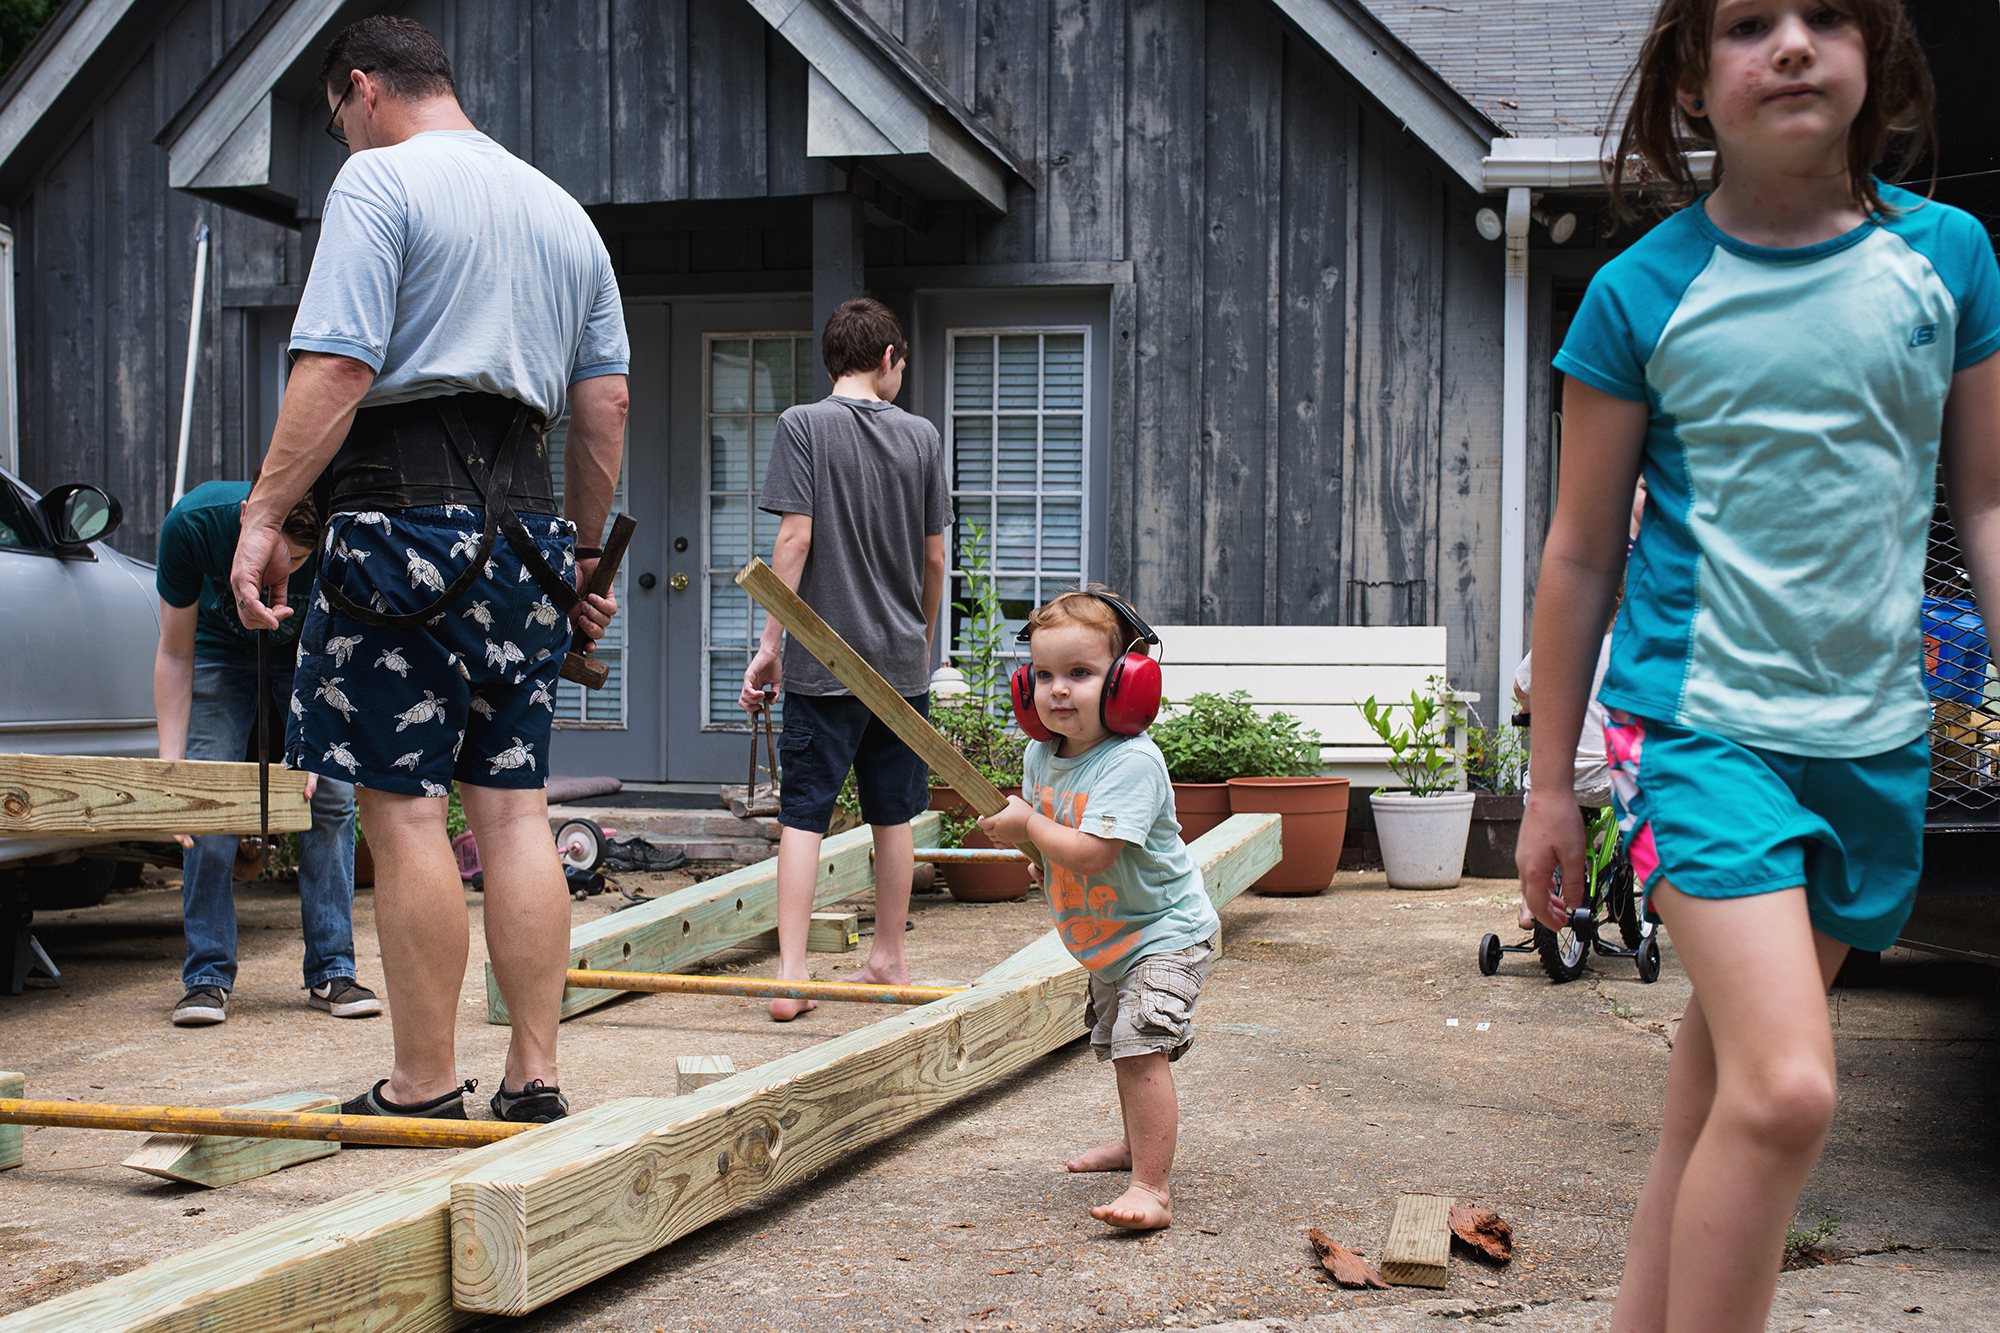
[0,1097,534,1147]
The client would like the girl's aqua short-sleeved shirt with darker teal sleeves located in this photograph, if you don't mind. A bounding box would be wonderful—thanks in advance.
[1556,186,2000,759]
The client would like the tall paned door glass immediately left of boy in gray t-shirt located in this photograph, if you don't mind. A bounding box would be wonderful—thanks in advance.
[702,332,812,731]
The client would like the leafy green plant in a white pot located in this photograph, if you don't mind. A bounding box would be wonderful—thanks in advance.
[1362,677,1472,889]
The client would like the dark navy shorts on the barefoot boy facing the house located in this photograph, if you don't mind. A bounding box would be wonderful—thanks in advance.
[778,691,930,833]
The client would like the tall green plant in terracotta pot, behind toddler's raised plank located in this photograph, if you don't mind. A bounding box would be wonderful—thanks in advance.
[930,522,1030,903]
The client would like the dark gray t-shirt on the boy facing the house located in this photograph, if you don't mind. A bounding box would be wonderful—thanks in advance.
[758,398,952,697]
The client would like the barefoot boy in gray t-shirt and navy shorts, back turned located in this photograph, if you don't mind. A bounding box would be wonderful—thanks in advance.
[740,296,952,1023]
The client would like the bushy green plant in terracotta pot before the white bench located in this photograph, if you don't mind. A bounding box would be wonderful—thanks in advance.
[1148,691,1348,895]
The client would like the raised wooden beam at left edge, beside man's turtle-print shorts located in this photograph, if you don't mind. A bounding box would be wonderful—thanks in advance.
[0,755,312,839]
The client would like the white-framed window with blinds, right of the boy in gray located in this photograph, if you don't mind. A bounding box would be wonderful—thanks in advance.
[944,328,1090,656]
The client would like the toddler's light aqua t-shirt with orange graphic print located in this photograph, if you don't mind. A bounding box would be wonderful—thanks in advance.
[1020,737,1222,981]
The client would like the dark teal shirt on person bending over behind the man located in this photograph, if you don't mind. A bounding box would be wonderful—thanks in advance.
[152,482,320,667]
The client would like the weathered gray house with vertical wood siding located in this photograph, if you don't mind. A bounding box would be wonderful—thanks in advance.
[0,0,1650,781]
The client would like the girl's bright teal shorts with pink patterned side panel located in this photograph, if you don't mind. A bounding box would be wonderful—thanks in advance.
[1604,709,1930,951]
